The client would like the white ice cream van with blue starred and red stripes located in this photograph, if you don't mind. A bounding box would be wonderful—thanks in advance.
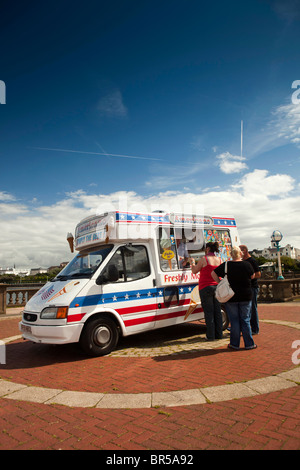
[19,211,240,356]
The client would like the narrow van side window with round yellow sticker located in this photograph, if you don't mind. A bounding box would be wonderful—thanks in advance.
[158,227,178,271]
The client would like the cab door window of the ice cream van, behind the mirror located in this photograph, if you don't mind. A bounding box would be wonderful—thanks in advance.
[104,245,150,282]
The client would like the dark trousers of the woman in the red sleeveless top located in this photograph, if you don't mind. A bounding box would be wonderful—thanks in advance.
[199,286,223,340]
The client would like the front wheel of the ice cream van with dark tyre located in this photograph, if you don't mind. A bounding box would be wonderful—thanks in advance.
[80,317,119,356]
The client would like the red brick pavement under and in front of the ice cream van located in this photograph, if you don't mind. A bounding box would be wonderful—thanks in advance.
[0,303,300,450]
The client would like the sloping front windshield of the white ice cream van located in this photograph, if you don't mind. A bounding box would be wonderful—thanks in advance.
[53,245,113,281]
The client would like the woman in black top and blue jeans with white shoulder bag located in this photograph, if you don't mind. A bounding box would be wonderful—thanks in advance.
[212,246,257,349]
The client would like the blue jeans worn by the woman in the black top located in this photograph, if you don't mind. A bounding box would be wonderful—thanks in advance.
[226,300,254,349]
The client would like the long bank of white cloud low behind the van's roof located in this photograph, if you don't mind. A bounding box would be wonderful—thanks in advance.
[0,170,300,267]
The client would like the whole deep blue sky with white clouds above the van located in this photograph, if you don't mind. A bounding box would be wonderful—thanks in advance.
[0,0,300,266]
